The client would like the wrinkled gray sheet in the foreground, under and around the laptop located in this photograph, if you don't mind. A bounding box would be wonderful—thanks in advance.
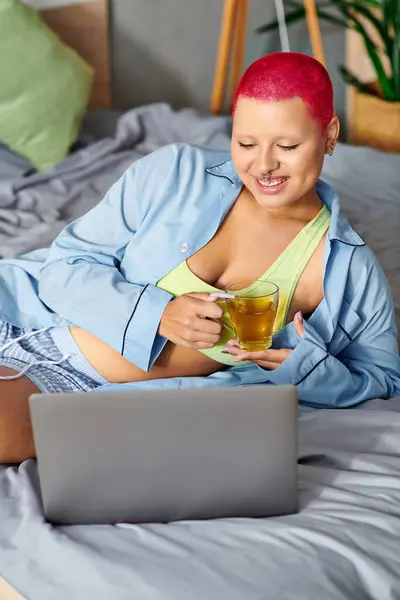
[0,398,400,600]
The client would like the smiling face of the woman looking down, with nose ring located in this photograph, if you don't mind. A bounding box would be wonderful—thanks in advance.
[231,98,339,209]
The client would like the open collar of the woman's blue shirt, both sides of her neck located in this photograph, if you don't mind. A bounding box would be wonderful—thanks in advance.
[206,157,365,246]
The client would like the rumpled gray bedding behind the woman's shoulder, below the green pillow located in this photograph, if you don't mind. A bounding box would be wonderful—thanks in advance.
[0,104,230,258]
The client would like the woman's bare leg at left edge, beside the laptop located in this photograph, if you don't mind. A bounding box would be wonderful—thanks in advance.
[0,367,40,464]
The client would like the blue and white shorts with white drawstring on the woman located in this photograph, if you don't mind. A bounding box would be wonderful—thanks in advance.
[0,321,108,394]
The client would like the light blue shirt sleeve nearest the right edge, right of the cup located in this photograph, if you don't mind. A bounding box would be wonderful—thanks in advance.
[260,248,400,408]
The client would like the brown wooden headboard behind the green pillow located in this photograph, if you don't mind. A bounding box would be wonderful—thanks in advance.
[40,0,111,108]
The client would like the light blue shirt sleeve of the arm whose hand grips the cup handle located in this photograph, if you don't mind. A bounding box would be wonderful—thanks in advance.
[39,147,175,371]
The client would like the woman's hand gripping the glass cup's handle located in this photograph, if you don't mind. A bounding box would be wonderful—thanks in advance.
[158,292,223,350]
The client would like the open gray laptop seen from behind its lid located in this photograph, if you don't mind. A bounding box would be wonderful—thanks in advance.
[30,386,297,524]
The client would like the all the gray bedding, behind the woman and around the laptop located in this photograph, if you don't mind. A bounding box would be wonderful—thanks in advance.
[0,104,400,600]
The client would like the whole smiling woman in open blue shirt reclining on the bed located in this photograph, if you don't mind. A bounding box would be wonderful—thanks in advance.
[0,53,400,461]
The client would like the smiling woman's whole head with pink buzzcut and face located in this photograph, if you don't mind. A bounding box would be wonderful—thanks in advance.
[231,52,339,210]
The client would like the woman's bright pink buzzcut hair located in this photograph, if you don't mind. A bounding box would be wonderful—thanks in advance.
[232,52,334,131]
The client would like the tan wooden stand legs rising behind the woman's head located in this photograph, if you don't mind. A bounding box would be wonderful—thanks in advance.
[210,0,325,114]
